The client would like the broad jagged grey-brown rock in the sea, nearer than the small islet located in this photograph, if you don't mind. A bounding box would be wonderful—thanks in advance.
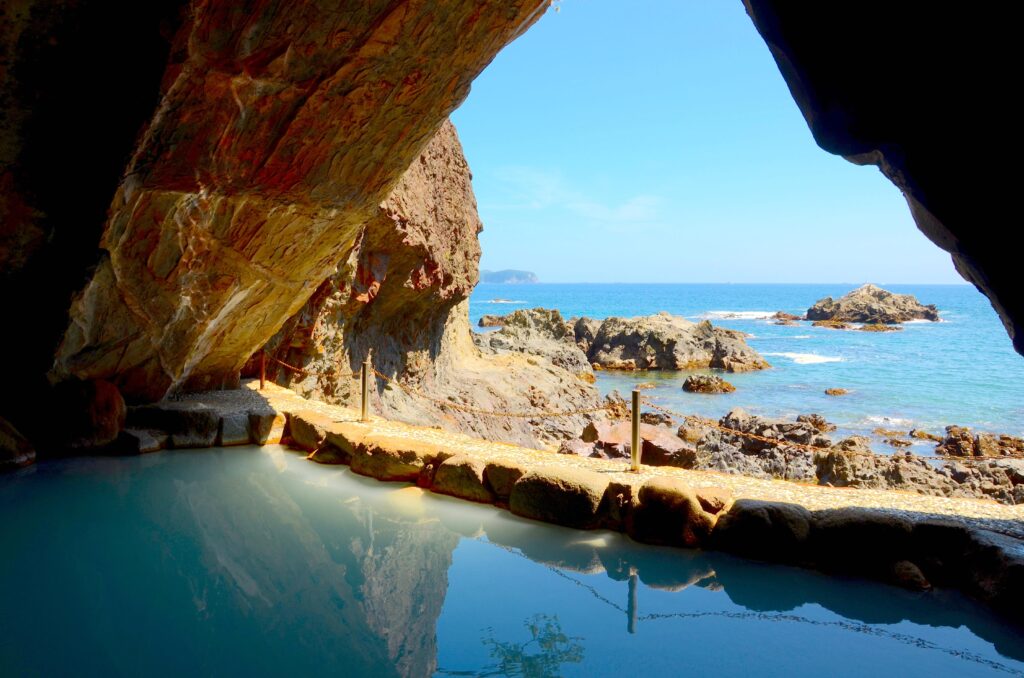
[574,312,770,372]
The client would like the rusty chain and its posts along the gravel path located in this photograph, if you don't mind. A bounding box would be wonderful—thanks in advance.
[260,353,1024,470]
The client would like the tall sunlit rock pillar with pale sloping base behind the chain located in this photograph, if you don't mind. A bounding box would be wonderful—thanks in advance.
[260,123,599,447]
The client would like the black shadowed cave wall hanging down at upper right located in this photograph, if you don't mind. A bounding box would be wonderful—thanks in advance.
[744,0,1024,353]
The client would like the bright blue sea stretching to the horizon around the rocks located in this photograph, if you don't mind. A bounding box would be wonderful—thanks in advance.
[470,284,1024,454]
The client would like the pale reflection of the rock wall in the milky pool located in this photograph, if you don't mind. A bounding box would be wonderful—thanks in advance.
[172,456,459,676]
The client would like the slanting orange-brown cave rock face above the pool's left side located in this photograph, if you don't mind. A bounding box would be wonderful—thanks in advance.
[44,0,546,399]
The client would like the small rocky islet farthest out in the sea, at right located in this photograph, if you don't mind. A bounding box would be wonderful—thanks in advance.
[807,284,939,325]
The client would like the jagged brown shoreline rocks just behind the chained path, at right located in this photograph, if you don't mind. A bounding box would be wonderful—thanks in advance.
[560,409,1024,505]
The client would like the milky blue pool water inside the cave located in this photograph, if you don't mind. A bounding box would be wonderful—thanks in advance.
[0,446,1024,678]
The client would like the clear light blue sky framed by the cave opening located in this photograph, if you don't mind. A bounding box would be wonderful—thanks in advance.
[453,0,964,284]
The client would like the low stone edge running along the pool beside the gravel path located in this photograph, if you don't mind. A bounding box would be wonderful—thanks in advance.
[122,384,1024,623]
